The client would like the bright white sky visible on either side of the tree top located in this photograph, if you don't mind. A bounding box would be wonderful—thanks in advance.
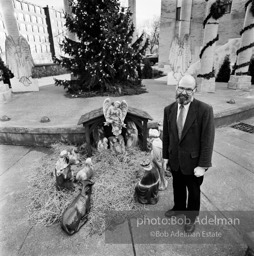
[26,0,161,28]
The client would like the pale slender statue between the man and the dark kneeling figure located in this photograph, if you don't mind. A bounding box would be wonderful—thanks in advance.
[149,129,168,190]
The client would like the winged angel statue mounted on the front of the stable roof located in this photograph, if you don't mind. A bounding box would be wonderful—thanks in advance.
[103,98,128,136]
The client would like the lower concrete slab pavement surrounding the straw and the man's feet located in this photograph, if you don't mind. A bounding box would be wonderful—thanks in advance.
[0,118,254,256]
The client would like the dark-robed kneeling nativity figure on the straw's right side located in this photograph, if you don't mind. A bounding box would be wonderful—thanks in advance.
[134,159,160,204]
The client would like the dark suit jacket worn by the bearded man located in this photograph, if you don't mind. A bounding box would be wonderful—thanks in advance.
[162,99,215,175]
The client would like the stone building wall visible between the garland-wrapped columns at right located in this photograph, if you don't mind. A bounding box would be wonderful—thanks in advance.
[159,0,245,66]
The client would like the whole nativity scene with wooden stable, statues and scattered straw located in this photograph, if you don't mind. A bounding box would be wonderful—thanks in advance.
[28,98,171,235]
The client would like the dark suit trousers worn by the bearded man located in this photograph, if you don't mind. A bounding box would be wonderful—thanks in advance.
[172,169,204,221]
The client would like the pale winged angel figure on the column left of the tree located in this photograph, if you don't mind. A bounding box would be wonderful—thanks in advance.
[5,35,34,86]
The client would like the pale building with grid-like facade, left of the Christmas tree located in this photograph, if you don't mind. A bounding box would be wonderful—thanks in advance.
[0,0,65,64]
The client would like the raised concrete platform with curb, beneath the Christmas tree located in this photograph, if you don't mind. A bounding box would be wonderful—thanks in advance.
[0,79,254,146]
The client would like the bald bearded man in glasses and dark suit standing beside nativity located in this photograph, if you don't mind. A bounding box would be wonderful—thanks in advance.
[163,75,215,233]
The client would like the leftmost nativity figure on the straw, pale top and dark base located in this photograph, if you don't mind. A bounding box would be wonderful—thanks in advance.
[53,149,80,190]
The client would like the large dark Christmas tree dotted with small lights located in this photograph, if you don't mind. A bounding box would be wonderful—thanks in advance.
[55,0,148,94]
